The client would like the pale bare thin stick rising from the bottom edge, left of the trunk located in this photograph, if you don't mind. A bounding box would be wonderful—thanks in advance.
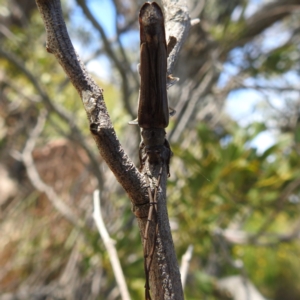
[93,190,130,300]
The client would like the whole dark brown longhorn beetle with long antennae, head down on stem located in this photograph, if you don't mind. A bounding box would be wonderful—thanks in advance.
[130,2,177,300]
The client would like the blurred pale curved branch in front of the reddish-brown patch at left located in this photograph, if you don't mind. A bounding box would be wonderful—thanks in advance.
[21,111,82,227]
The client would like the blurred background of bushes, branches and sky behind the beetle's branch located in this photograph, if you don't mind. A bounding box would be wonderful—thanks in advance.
[0,0,300,300]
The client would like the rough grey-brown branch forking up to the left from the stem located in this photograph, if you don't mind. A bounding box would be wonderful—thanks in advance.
[37,0,148,211]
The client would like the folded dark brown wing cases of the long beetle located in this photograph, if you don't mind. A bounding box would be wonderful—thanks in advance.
[138,2,169,128]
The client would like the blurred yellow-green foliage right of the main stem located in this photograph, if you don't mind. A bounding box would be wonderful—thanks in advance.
[169,122,300,299]
